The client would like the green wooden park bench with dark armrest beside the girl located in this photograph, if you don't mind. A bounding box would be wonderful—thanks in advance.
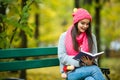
[0,47,110,80]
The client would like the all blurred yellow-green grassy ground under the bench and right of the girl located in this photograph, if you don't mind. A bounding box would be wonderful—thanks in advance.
[0,58,120,80]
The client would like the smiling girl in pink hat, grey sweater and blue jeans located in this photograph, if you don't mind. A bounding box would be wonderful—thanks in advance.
[58,8,105,80]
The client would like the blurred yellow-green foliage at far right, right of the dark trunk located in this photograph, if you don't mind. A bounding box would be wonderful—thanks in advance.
[101,0,120,48]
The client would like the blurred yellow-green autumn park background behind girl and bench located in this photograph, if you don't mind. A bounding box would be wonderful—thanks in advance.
[0,0,120,80]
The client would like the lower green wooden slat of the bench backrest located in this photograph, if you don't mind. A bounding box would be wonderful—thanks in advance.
[0,58,59,71]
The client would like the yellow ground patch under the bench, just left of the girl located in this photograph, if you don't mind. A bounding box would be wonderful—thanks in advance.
[27,66,62,80]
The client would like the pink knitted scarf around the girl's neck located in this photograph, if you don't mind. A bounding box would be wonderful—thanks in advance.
[65,27,89,56]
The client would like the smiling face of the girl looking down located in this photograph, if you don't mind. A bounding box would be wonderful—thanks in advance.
[78,19,90,33]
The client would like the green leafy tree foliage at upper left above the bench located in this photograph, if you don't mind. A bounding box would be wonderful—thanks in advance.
[0,0,32,48]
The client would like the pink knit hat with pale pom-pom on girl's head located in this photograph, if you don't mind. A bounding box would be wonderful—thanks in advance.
[72,8,92,24]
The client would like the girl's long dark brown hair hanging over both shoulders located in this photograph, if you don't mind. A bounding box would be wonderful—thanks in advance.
[71,23,93,52]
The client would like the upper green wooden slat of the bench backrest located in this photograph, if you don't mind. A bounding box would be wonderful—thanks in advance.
[0,47,57,59]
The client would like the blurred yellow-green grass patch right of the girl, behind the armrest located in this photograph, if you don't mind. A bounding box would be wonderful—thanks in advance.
[101,58,120,80]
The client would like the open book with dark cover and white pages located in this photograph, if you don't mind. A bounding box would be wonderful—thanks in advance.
[73,51,104,61]
